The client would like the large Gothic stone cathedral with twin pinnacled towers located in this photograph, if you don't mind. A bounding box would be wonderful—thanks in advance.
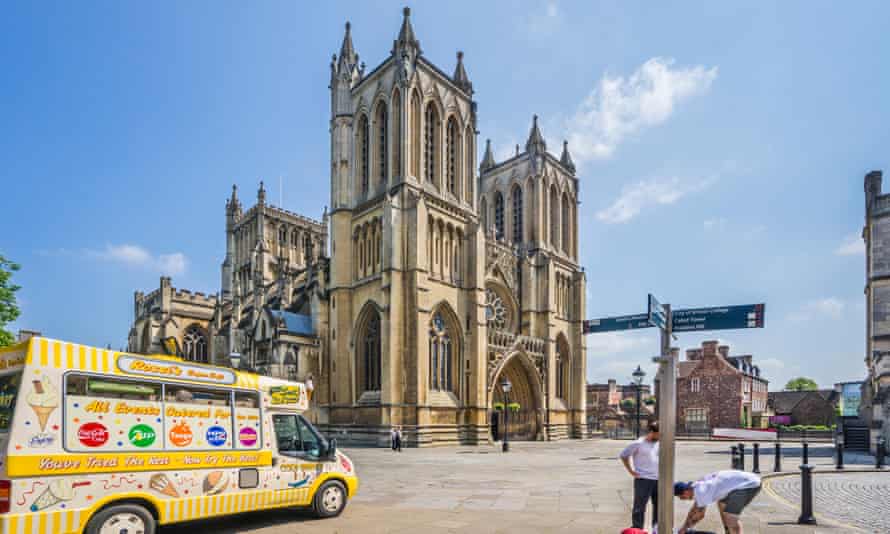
[129,8,586,446]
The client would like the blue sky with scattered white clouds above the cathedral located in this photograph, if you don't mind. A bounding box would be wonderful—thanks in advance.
[0,1,890,388]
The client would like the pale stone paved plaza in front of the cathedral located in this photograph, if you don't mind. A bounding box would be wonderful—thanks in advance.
[160,440,890,534]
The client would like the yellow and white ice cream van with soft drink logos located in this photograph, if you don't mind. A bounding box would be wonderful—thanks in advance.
[0,338,358,534]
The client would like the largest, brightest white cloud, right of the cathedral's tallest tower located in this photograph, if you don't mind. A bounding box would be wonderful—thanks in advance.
[566,57,717,164]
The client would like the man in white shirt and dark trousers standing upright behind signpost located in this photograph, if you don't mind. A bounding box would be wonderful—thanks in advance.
[618,421,658,529]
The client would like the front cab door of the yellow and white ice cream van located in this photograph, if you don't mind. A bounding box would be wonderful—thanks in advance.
[272,414,326,504]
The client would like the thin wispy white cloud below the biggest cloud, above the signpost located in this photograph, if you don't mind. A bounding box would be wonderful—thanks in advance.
[596,177,717,224]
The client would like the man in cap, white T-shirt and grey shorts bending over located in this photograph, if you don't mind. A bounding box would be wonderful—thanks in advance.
[674,470,760,534]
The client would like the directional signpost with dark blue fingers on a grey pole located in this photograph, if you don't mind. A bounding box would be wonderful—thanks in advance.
[583,293,766,532]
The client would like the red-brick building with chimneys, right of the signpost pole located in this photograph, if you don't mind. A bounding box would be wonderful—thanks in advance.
[677,341,769,431]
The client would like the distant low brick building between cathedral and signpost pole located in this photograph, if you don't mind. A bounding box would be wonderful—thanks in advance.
[587,378,655,431]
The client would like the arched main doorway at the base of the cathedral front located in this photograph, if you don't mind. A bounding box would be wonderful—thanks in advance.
[489,352,542,441]
